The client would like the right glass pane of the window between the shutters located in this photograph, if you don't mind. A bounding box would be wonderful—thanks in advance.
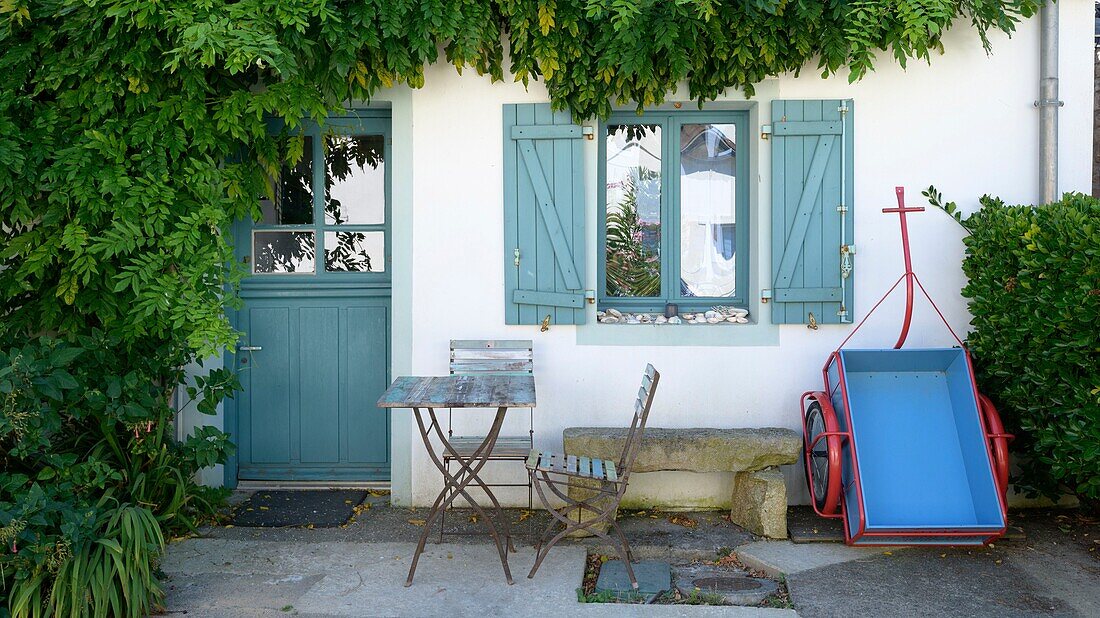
[680,124,737,297]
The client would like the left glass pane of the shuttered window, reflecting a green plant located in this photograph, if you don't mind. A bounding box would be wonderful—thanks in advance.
[605,124,661,297]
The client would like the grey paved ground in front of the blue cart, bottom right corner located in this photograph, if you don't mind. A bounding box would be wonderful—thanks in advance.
[787,511,1100,618]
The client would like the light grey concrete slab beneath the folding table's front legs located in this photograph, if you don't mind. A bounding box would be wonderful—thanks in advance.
[162,539,794,618]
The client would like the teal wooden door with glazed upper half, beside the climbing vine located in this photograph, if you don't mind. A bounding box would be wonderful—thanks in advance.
[227,112,392,483]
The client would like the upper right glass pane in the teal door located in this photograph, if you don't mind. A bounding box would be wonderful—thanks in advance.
[325,135,386,225]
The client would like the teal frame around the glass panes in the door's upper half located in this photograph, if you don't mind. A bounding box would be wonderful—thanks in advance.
[242,110,393,285]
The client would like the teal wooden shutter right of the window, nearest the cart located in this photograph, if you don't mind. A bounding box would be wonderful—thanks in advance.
[766,99,855,324]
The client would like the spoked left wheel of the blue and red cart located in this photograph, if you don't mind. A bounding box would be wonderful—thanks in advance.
[802,394,840,515]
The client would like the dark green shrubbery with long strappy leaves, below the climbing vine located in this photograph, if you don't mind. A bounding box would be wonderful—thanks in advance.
[0,329,237,617]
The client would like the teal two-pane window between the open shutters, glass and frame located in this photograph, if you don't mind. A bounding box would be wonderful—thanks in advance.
[598,111,748,311]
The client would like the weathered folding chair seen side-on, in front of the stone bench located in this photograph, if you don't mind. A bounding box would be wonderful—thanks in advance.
[527,365,661,589]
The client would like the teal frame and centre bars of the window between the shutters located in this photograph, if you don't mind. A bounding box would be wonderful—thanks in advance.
[596,110,752,312]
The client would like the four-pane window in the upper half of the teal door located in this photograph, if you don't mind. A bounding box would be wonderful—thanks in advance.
[252,119,388,276]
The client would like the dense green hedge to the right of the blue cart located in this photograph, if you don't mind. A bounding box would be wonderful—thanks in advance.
[933,189,1100,508]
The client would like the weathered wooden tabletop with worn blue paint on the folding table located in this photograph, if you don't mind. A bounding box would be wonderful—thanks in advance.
[378,375,535,408]
